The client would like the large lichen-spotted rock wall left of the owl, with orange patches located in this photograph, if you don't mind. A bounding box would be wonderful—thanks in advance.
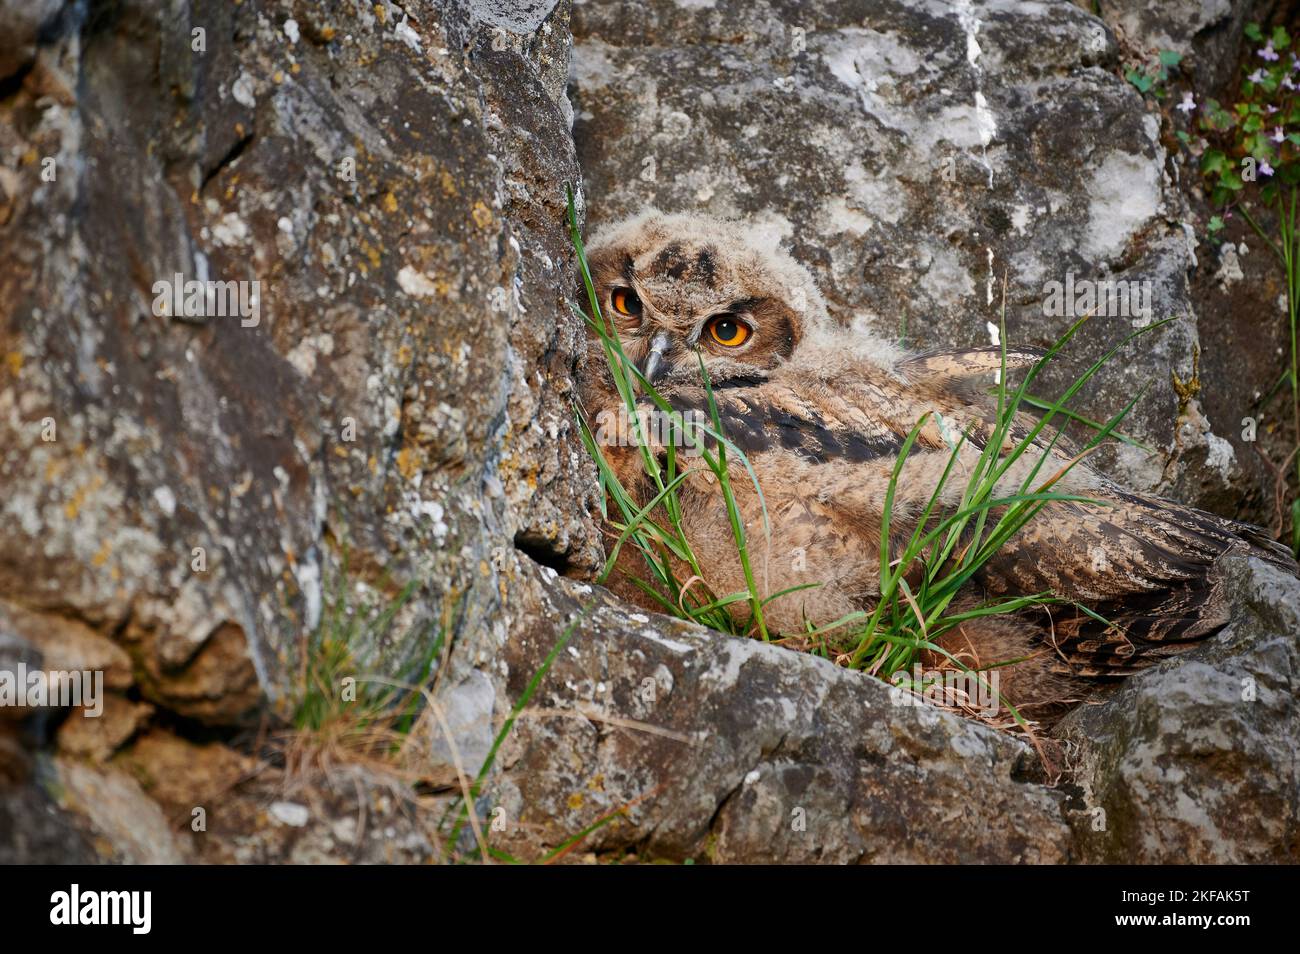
[0,3,597,723]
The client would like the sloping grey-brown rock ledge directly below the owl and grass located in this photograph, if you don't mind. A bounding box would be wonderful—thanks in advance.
[488,571,1070,863]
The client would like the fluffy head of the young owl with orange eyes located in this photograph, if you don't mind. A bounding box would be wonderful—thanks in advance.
[579,209,829,386]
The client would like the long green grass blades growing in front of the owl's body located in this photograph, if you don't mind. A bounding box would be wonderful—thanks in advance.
[568,184,1173,725]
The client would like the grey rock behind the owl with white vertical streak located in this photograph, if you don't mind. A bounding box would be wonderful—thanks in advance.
[573,0,1247,502]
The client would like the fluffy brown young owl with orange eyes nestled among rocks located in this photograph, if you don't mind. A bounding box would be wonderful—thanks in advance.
[580,211,1295,717]
